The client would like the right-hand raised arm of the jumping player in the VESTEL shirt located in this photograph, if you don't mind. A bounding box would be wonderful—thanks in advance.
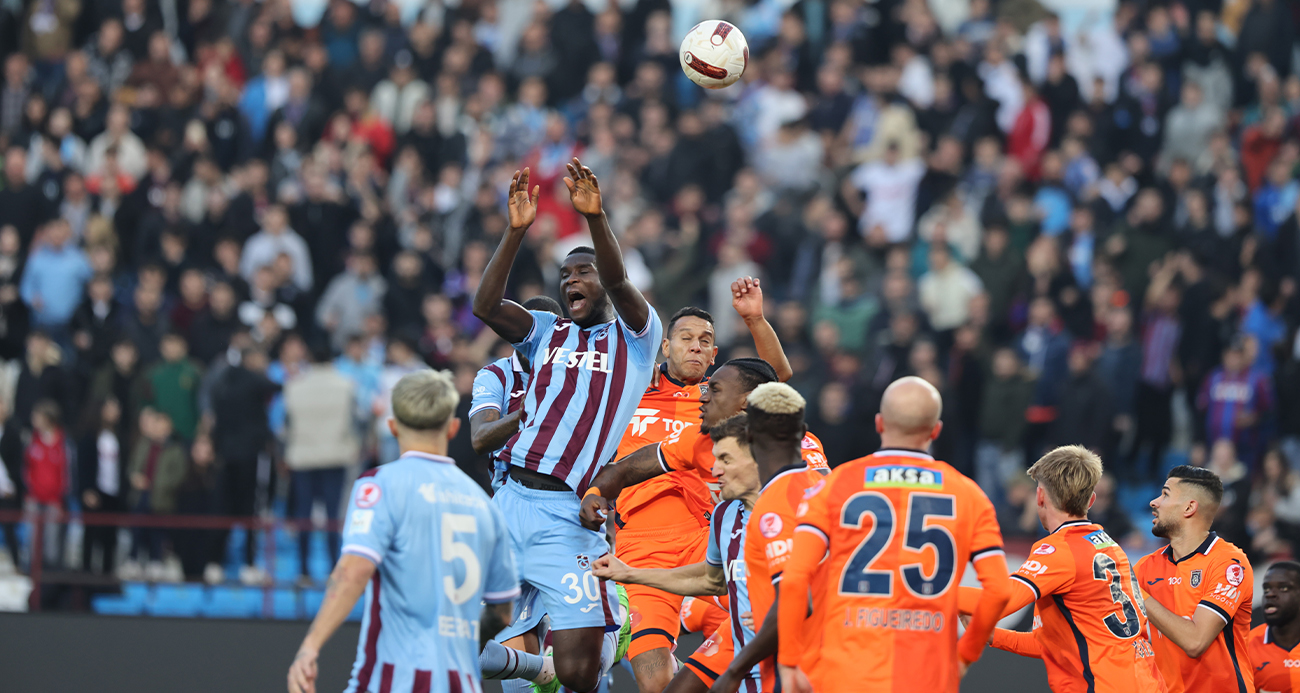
[566,156,650,333]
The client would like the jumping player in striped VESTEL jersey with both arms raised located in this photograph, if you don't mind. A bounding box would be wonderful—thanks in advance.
[473,159,663,693]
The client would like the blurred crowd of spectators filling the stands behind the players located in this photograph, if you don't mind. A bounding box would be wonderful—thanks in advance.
[0,0,1300,582]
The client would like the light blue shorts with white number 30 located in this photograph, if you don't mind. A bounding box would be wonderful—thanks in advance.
[493,480,623,641]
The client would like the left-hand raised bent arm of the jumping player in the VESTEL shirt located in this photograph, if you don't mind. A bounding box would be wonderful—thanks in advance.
[473,168,538,345]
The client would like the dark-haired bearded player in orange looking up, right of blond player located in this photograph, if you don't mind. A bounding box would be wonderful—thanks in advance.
[1138,464,1255,693]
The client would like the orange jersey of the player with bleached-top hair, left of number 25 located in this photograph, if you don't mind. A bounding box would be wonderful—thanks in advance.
[745,460,827,690]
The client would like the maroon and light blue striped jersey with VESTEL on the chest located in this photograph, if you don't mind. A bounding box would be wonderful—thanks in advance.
[502,311,663,495]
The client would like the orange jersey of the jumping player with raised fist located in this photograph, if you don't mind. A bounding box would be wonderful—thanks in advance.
[614,367,715,530]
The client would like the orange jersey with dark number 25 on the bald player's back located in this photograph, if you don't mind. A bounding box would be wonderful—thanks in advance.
[780,450,1006,693]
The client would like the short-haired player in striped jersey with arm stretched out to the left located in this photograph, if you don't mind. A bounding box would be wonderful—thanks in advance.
[594,413,761,693]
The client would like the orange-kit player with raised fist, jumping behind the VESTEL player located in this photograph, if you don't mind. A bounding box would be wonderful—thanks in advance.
[614,277,790,693]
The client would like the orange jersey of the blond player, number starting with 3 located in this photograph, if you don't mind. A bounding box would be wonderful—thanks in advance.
[1011,520,1165,693]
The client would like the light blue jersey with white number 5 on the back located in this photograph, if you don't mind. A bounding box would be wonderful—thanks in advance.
[343,452,519,693]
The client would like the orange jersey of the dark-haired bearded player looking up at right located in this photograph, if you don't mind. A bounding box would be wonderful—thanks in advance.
[1138,532,1255,693]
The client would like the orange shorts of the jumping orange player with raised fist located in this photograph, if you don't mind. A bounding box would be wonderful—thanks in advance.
[615,517,709,659]
